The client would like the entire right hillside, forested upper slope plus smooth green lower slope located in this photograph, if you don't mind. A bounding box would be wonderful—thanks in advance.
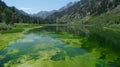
[47,0,120,24]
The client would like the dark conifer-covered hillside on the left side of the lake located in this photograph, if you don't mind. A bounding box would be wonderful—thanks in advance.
[0,0,42,25]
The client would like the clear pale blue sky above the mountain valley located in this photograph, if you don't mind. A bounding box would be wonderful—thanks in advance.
[3,0,79,14]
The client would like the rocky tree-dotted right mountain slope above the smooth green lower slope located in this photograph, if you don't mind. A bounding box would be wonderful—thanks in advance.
[47,0,120,24]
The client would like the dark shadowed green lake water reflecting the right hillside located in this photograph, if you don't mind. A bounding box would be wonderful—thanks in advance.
[43,25,120,66]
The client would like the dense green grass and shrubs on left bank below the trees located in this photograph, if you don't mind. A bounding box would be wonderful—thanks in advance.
[0,23,39,34]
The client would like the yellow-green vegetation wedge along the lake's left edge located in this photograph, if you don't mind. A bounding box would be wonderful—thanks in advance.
[0,24,38,50]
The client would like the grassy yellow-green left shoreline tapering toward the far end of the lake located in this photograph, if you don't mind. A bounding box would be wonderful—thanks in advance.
[0,24,42,51]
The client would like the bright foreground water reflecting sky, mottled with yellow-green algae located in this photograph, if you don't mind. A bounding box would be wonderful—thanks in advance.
[0,26,116,67]
